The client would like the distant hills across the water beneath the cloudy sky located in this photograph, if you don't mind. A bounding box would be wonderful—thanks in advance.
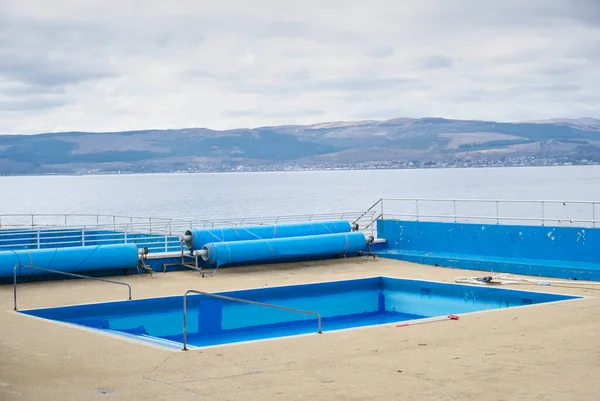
[0,118,600,174]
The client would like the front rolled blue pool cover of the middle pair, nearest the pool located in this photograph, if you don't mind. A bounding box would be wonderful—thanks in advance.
[203,232,367,266]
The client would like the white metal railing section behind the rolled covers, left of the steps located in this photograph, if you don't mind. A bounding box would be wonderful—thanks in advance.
[0,212,373,253]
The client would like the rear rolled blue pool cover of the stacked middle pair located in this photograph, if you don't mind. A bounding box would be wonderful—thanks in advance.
[185,220,351,251]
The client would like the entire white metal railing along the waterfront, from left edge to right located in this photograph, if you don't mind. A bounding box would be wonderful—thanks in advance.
[0,198,600,253]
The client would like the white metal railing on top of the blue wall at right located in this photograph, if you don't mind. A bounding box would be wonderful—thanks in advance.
[360,198,600,228]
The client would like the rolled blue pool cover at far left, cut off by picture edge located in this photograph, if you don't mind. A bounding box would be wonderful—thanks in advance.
[0,244,138,278]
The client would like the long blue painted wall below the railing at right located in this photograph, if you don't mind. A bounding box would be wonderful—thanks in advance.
[377,219,600,281]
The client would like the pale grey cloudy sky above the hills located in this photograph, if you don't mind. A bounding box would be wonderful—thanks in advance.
[0,0,600,133]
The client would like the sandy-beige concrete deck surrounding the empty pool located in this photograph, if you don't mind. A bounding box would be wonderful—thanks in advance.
[0,258,600,401]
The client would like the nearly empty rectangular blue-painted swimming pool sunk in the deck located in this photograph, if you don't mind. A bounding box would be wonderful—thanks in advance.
[20,277,580,348]
